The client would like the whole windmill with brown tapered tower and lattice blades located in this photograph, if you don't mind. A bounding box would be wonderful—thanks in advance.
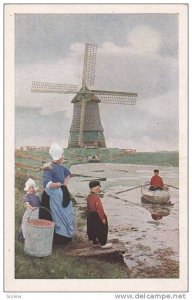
[31,44,137,148]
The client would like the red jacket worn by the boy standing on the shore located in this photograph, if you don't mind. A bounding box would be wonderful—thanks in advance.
[87,193,105,220]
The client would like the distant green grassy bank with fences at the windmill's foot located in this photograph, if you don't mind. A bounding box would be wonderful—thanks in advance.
[16,148,179,167]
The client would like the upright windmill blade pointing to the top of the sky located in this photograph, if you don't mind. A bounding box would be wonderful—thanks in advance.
[82,44,97,87]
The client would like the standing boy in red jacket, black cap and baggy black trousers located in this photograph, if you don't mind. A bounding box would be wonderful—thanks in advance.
[87,180,112,249]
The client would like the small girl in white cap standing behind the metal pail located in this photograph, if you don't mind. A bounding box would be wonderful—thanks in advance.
[18,178,40,241]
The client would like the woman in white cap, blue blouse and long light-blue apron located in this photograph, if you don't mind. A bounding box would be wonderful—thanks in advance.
[39,144,74,245]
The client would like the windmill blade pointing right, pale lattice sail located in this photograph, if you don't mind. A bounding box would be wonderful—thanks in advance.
[92,90,137,105]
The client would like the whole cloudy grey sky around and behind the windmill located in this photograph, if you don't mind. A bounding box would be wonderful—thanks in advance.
[15,13,179,151]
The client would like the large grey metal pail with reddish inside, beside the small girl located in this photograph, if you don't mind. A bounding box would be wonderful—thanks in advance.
[24,208,55,257]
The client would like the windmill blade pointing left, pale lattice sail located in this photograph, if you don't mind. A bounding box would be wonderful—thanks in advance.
[31,81,78,94]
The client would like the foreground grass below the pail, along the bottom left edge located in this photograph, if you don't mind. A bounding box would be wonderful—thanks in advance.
[15,242,128,279]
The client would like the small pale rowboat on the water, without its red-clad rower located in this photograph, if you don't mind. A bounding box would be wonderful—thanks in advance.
[141,184,171,204]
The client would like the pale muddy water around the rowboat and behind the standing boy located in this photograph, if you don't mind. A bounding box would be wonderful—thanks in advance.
[69,163,179,277]
